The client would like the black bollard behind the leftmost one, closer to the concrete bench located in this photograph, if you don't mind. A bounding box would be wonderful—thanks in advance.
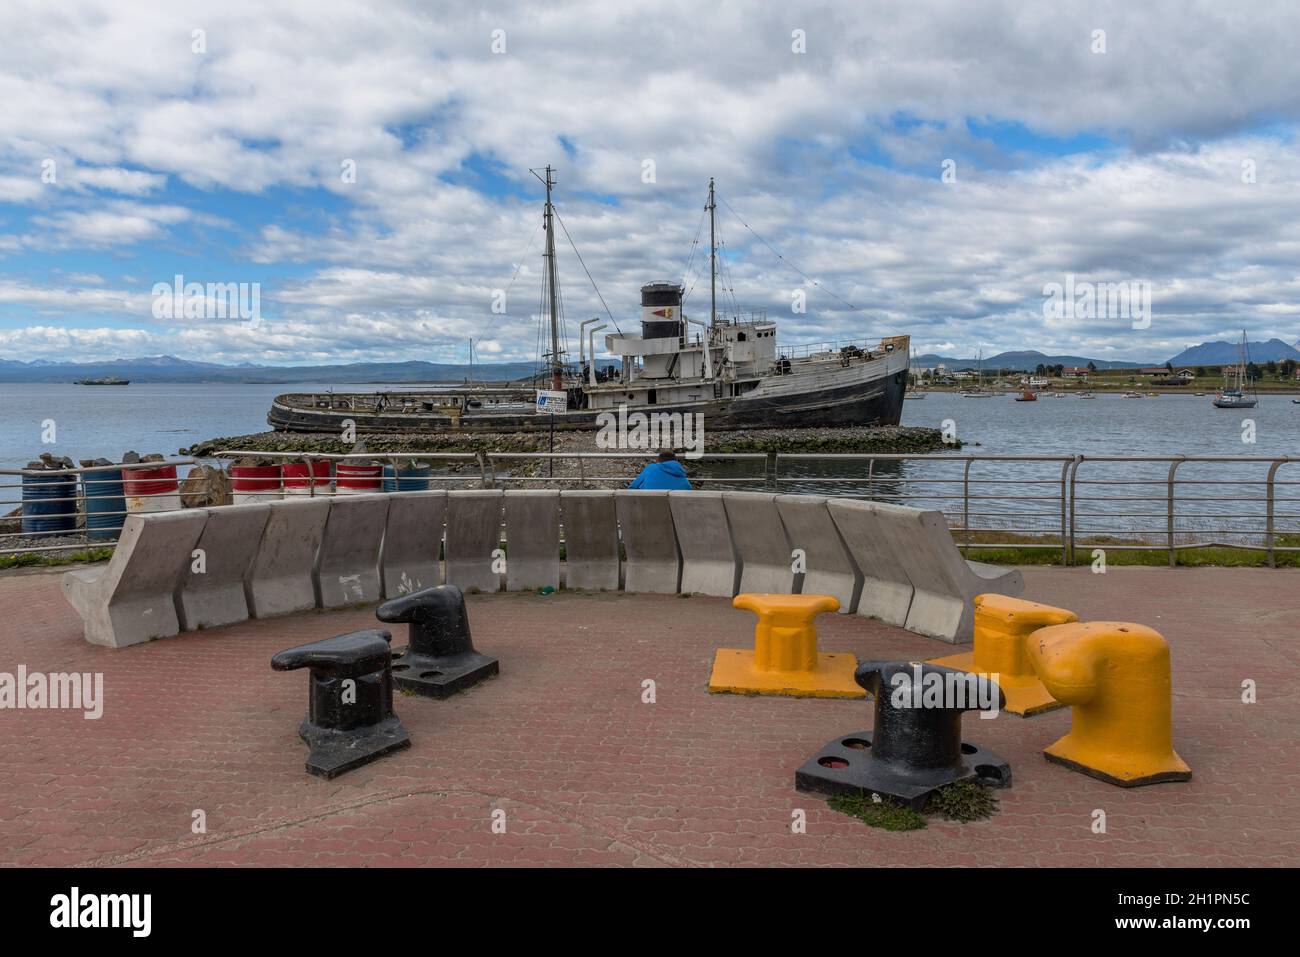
[374,585,501,698]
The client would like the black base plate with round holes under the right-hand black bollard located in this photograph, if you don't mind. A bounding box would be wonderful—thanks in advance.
[794,731,1011,811]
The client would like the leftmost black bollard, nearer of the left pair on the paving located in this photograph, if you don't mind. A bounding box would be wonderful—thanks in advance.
[270,628,411,778]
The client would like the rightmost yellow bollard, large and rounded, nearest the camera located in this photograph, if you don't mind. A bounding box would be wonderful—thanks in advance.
[1028,622,1192,788]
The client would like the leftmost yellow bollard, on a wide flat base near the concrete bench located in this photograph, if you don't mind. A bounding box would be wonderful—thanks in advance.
[709,593,867,698]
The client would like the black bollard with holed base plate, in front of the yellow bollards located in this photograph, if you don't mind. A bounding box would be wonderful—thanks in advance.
[794,662,1011,810]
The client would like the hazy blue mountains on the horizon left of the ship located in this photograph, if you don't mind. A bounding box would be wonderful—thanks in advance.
[0,355,537,384]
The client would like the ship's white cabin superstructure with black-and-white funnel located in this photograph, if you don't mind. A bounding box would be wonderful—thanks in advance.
[586,282,779,408]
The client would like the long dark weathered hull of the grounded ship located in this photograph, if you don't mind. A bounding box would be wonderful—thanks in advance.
[267,371,907,433]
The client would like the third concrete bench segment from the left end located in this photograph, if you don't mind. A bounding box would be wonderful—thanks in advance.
[244,498,329,618]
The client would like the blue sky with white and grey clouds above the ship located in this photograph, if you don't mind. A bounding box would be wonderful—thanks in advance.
[0,0,1300,364]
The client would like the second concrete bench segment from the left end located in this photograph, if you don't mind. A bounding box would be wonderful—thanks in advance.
[176,505,270,632]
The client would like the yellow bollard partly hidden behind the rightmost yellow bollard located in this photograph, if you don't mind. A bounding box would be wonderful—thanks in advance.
[930,594,1079,718]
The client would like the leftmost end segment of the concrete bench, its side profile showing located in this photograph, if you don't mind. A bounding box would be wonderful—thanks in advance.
[60,510,208,648]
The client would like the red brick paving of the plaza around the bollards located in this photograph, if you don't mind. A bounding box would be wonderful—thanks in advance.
[0,568,1300,867]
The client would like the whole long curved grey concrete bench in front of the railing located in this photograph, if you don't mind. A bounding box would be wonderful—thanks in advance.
[64,489,1024,655]
